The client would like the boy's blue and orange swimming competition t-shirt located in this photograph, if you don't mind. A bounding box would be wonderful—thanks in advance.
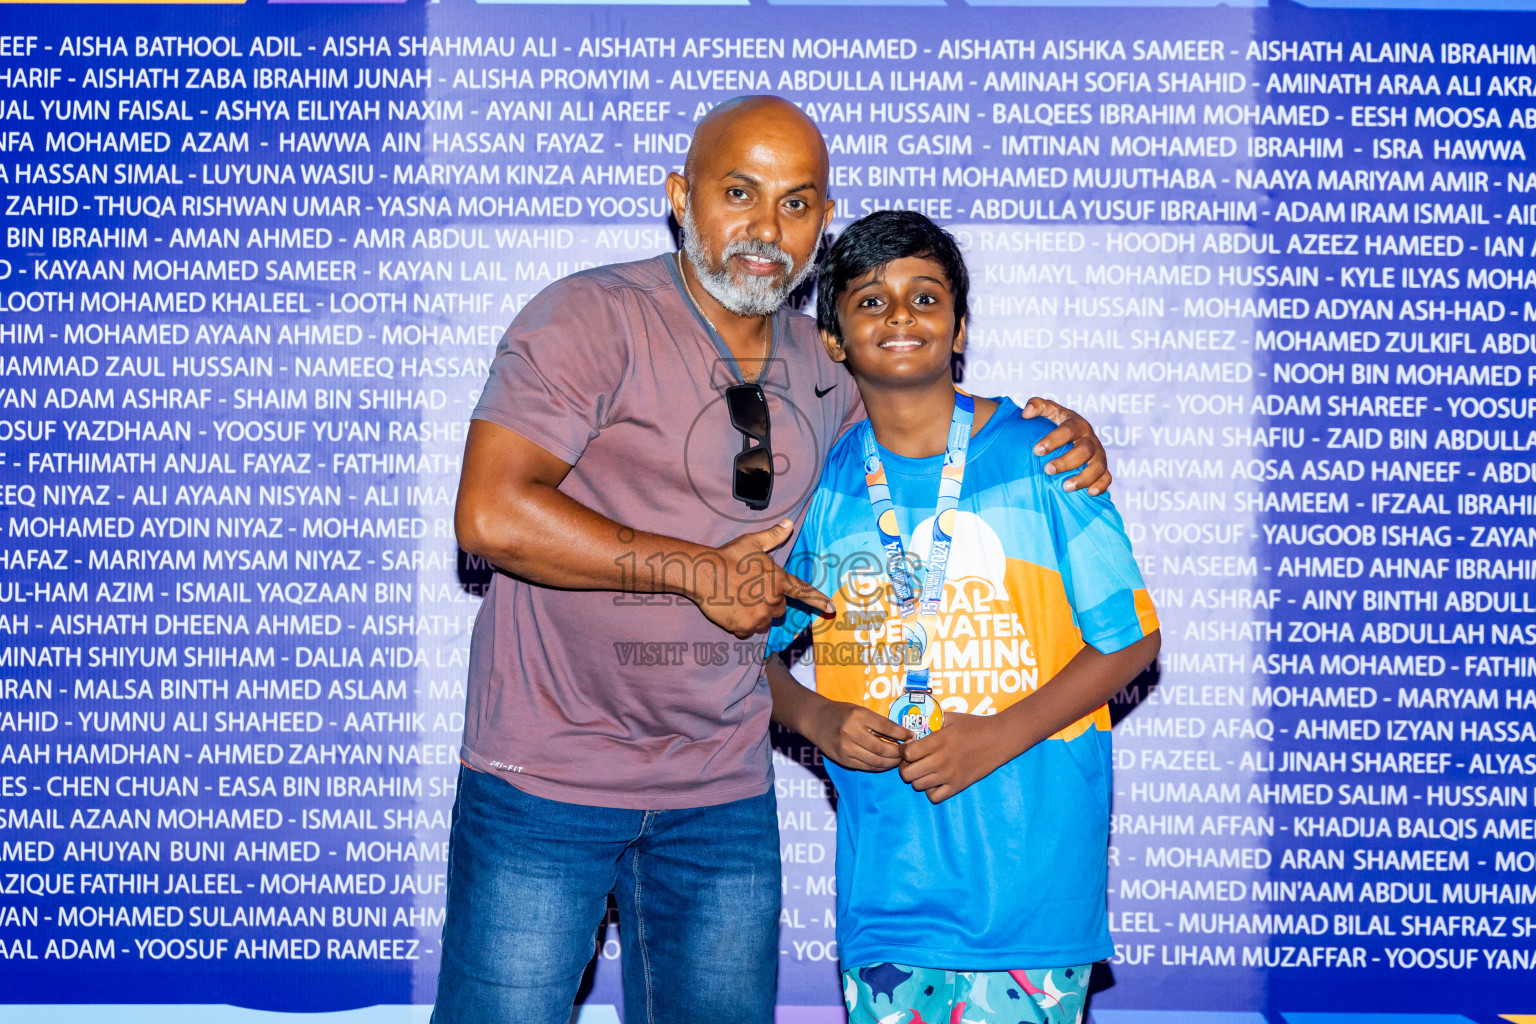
[768,399,1158,970]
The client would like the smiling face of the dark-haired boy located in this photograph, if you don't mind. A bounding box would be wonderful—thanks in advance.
[822,256,965,387]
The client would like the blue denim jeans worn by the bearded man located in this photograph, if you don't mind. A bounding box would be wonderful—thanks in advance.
[432,768,782,1024]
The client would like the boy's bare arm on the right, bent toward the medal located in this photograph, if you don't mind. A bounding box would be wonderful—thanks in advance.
[897,629,1163,803]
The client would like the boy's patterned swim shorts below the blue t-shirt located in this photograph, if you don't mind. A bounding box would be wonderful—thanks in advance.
[843,964,1092,1024]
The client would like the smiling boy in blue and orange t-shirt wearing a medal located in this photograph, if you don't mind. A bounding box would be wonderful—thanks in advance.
[768,210,1160,1024]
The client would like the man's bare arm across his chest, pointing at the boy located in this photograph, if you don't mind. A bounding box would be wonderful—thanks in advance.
[453,419,831,639]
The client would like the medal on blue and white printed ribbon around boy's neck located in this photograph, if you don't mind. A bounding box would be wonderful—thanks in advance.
[862,388,975,738]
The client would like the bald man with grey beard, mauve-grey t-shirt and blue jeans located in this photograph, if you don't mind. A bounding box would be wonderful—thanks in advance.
[433,97,1109,1024]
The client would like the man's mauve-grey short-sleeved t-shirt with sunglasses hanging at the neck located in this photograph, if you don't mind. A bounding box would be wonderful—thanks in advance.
[462,256,863,811]
